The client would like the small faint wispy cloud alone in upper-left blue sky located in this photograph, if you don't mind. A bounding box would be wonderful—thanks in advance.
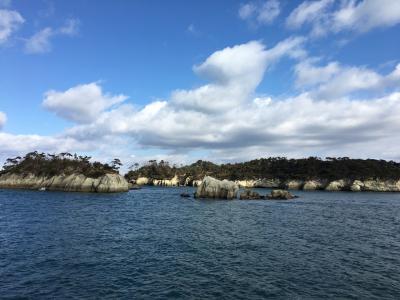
[25,19,79,54]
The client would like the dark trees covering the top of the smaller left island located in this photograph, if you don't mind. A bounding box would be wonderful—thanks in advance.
[0,151,122,178]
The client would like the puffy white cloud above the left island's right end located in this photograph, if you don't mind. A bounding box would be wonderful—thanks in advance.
[43,82,127,123]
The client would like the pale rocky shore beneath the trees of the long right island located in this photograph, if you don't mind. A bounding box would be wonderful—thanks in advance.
[132,175,400,192]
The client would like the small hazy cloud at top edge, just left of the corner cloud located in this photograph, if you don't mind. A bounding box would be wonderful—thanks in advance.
[238,0,281,26]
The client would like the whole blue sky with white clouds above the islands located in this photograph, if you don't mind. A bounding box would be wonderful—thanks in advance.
[0,0,400,165]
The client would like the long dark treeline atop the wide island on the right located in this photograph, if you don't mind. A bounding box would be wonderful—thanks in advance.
[125,157,400,180]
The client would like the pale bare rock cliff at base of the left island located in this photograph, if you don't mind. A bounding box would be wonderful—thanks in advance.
[0,174,129,193]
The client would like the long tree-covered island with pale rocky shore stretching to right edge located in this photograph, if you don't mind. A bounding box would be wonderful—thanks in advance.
[125,157,400,192]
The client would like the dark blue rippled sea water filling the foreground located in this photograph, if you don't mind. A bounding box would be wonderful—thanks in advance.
[0,187,400,299]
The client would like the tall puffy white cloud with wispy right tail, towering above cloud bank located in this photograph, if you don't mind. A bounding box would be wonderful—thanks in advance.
[171,37,305,112]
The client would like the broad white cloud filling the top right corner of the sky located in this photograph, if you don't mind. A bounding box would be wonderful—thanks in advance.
[286,0,400,36]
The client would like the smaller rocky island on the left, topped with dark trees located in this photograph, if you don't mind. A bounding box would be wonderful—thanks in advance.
[0,152,129,193]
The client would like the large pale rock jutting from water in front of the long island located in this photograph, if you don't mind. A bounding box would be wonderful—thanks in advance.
[195,176,239,199]
